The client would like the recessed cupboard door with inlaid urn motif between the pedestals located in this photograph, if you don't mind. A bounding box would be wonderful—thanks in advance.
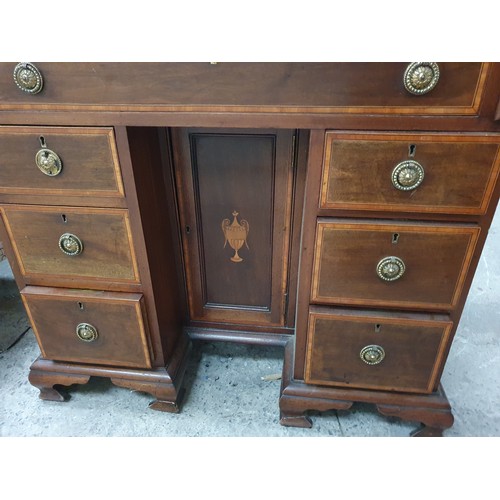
[172,129,294,326]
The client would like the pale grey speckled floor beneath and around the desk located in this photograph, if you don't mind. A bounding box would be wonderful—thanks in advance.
[0,205,500,437]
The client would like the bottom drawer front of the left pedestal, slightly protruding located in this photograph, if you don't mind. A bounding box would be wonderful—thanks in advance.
[21,286,151,368]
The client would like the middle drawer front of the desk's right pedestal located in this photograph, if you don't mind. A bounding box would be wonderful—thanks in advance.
[311,219,480,310]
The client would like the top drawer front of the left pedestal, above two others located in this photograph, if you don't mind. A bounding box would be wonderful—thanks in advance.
[0,127,124,198]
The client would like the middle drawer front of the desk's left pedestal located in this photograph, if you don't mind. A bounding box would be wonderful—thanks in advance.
[2,206,139,283]
